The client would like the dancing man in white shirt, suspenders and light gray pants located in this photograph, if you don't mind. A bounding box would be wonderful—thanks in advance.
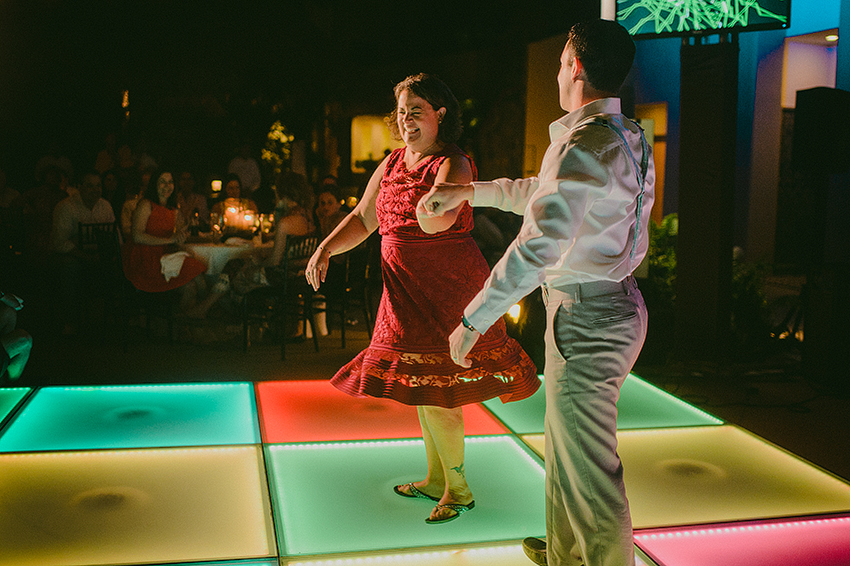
[423,20,655,566]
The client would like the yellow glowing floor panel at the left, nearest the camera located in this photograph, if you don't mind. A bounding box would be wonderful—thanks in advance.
[0,446,276,566]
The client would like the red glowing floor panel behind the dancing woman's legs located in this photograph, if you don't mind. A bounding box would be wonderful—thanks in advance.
[252,381,507,444]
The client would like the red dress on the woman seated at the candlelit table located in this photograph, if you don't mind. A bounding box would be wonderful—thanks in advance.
[121,203,207,293]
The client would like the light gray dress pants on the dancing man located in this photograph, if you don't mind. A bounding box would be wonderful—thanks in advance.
[543,277,647,566]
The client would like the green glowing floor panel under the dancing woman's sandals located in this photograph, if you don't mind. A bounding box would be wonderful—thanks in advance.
[266,435,545,556]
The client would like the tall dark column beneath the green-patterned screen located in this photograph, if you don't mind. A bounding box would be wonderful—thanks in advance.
[675,42,738,361]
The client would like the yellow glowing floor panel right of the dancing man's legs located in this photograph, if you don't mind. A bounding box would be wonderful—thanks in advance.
[523,425,850,529]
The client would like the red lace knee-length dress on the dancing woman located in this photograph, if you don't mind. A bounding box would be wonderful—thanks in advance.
[331,145,540,408]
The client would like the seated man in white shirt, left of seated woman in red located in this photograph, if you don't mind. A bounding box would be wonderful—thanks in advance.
[50,171,115,335]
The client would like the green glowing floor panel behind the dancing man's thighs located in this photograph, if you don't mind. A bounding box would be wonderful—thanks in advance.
[484,374,722,434]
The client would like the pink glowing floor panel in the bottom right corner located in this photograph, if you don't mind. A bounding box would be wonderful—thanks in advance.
[635,516,850,566]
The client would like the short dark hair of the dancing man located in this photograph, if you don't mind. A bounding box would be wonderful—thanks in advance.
[567,20,635,93]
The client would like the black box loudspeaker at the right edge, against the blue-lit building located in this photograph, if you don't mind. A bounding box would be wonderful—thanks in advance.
[791,87,850,175]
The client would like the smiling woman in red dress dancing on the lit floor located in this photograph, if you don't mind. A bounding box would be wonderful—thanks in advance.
[306,75,540,523]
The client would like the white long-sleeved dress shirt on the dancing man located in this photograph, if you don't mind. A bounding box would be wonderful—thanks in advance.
[465,98,655,333]
